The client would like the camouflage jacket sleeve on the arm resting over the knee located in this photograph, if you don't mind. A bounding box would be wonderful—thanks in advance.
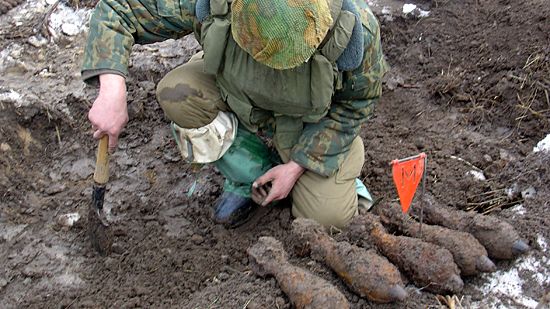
[291,3,387,176]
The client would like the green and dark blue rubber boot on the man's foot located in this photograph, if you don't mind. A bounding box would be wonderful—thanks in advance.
[213,127,276,228]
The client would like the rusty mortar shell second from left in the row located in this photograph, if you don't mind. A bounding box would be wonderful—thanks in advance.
[292,218,407,303]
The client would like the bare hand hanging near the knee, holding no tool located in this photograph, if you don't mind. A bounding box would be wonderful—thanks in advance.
[252,161,305,206]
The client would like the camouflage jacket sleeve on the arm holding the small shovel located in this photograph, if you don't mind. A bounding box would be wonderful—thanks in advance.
[82,0,196,83]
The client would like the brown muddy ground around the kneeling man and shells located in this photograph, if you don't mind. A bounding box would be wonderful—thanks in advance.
[0,0,550,308]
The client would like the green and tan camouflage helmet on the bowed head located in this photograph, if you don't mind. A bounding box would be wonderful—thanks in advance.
[231,0,332,70]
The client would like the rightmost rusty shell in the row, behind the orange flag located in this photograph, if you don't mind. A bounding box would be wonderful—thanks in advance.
[415,196,529,260]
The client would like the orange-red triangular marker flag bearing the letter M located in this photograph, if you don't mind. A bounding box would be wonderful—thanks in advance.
[392,153,426,213]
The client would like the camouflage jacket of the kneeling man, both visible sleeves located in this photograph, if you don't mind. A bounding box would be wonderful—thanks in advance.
[82,0,387,176]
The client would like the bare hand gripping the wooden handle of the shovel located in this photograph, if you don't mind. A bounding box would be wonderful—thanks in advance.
[88,74,128,151]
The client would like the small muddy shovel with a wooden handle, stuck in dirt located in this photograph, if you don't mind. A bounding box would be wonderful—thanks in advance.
[88,135,113,256]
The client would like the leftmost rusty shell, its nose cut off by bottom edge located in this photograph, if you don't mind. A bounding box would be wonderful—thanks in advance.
[247,237,349,309]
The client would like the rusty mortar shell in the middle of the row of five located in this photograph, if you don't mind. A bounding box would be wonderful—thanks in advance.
[348,213,464,293]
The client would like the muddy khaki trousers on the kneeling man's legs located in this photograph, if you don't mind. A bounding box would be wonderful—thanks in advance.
[157,53,364,228]
